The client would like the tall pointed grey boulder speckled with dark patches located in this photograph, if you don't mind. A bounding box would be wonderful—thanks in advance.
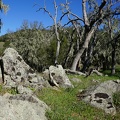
[2,48,47,87]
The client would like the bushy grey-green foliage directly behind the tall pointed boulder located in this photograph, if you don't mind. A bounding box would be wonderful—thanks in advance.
[11,29,52,71]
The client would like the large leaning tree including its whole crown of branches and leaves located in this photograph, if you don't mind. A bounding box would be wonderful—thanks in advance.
[62,0,120,70]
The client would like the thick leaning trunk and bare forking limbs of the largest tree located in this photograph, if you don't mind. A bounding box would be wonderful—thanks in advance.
[62,0,119,71]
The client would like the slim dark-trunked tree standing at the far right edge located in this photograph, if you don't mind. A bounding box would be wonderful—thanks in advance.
[105,16,120,74]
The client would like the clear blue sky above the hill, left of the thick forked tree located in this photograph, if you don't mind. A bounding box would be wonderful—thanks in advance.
[0,0,81,36]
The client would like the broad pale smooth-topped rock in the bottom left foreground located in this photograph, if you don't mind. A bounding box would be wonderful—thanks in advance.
[0,94,49,120]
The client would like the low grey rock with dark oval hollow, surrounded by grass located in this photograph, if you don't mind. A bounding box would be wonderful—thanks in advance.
[79,80,120,115]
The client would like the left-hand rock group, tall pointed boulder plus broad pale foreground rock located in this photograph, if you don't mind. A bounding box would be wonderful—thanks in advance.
[0,48,49,120]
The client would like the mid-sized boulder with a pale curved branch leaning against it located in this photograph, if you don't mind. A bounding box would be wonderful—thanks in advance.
[43,65,73,88]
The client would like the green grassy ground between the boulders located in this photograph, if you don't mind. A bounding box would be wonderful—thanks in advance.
[38,71,120,120]
